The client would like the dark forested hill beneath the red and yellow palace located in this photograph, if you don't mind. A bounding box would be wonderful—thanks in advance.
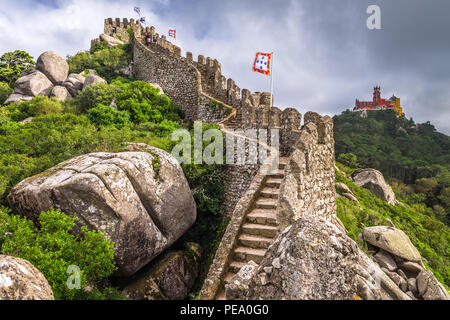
[333,110,450,226]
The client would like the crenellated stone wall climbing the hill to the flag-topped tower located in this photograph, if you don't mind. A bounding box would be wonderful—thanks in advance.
[104,18,301,136]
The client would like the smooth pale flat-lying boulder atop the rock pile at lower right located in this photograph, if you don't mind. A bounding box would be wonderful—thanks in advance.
[363,226,422,262]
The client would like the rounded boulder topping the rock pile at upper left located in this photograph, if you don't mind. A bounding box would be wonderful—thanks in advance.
[36,51,69,85]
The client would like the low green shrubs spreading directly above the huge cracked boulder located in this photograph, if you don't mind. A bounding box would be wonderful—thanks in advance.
[0,109,179,203]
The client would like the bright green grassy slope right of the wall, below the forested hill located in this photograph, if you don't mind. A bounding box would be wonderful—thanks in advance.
[336,164,450,286]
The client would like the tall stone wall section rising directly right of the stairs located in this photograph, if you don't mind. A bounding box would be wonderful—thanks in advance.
[278,112,336,228]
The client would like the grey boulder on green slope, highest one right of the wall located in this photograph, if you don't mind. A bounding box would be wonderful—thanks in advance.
[351,169,397,205]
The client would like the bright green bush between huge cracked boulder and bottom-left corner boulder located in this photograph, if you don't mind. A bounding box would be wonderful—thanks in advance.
[0,209,117,299]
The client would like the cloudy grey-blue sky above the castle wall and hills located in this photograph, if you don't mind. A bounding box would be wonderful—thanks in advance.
[0,0,450,134]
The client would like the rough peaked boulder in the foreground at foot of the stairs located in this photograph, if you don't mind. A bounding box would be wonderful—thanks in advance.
[244,215,358,300]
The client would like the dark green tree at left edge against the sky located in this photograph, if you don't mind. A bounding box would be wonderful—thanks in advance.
[0,50,36,87]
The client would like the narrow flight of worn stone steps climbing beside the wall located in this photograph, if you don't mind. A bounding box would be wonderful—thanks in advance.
[216,158,287,300]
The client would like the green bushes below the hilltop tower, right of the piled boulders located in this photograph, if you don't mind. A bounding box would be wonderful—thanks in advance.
[67,42,132,82]
